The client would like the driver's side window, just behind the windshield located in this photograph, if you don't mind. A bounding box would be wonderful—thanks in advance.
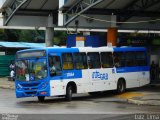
[49,56,62,76]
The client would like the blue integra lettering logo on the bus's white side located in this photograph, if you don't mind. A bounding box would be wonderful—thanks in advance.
[92,71,108,80]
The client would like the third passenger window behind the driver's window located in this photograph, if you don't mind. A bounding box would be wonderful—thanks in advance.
[87,52,101,69]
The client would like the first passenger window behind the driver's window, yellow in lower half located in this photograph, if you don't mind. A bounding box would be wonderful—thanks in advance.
[62,53,73,70]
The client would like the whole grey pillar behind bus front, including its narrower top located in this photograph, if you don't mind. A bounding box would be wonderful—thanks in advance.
[45,14,54,47]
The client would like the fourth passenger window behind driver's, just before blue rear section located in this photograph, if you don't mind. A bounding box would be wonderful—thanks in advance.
[101,52,113,68]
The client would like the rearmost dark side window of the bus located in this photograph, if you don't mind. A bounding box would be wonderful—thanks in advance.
[136,52,147,66]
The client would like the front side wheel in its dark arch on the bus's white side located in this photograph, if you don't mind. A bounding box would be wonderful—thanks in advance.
[65,82,77,101]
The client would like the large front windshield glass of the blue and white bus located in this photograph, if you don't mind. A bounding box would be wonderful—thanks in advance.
[16,59,47,81]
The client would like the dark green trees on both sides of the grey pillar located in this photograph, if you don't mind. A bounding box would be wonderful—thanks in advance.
[0,29,67,45]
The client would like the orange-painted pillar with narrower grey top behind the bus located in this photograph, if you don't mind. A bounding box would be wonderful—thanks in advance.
[107,15,118,46]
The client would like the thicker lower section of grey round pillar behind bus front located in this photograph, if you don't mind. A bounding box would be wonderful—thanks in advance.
[45,27,54,47]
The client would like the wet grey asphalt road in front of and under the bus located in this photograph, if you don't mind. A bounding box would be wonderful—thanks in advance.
[0,89,160,120]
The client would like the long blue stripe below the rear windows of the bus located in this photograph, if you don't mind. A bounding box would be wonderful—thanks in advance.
[116,66,150,73]
